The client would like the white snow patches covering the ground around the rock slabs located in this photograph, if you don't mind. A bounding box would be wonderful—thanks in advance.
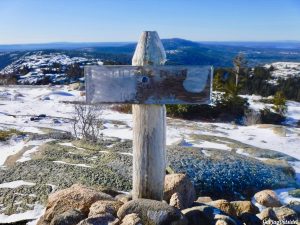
[0,86,300,222]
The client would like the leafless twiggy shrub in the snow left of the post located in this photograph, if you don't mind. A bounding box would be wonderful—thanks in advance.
[72,104,103,142]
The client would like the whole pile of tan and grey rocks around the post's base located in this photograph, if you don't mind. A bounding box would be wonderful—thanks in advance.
[38,174,299,225]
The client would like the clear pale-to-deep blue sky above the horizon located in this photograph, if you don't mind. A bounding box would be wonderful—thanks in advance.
[0,0,300,44]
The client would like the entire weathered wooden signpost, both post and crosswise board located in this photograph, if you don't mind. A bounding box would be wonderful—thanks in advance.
[85,31,213,201]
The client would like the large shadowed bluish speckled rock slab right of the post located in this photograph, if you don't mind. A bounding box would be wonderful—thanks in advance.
[167,146,296,201]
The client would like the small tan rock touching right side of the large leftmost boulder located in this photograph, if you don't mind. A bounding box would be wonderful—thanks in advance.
[89,200,123,217]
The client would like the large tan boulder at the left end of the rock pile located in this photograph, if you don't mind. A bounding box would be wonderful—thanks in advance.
[44,184,113,222]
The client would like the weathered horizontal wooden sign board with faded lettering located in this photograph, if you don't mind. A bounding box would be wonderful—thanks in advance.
[85,66,213,104]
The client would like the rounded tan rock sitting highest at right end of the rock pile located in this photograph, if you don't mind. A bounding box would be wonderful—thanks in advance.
[254,190,281,207]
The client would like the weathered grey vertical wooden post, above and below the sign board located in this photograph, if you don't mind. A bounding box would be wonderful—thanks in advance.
[132,31,166,201]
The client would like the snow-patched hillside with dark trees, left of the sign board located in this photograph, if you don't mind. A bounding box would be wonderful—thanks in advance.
[0,51,102,85]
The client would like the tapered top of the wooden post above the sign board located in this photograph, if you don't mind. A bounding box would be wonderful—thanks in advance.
[132,31,167,66]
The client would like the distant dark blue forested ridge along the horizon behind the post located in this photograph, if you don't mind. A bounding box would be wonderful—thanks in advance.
[0,38,300,69]
